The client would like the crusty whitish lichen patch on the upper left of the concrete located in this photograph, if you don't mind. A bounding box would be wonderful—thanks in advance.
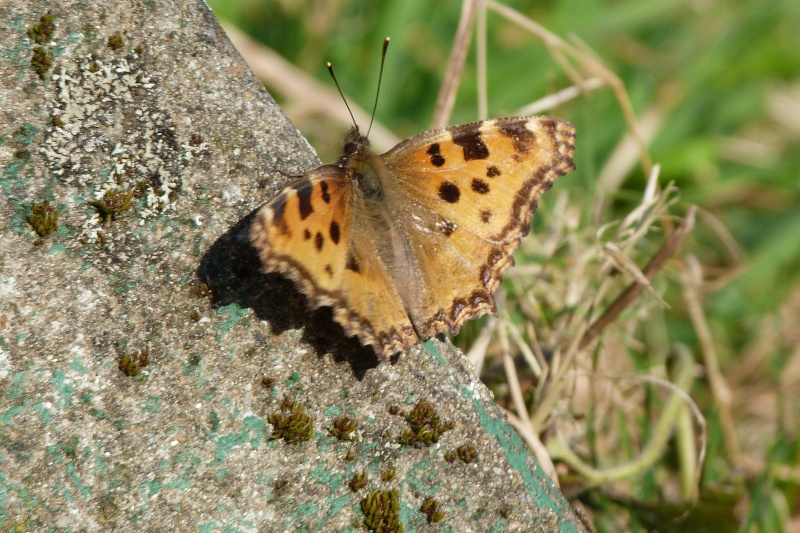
[40,54,207,243]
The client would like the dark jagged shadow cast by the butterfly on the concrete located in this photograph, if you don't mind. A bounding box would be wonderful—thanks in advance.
[197,211,379,380]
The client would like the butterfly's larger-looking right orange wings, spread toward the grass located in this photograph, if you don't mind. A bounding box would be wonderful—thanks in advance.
[382,117,575,338]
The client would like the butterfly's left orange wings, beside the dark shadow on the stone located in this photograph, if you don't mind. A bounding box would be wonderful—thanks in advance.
[250,165,419,357]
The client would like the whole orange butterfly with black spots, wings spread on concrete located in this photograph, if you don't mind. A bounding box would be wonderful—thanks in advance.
[250,116,575,361]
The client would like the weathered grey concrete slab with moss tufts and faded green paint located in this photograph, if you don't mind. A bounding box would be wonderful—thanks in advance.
[0,0,581,532]
